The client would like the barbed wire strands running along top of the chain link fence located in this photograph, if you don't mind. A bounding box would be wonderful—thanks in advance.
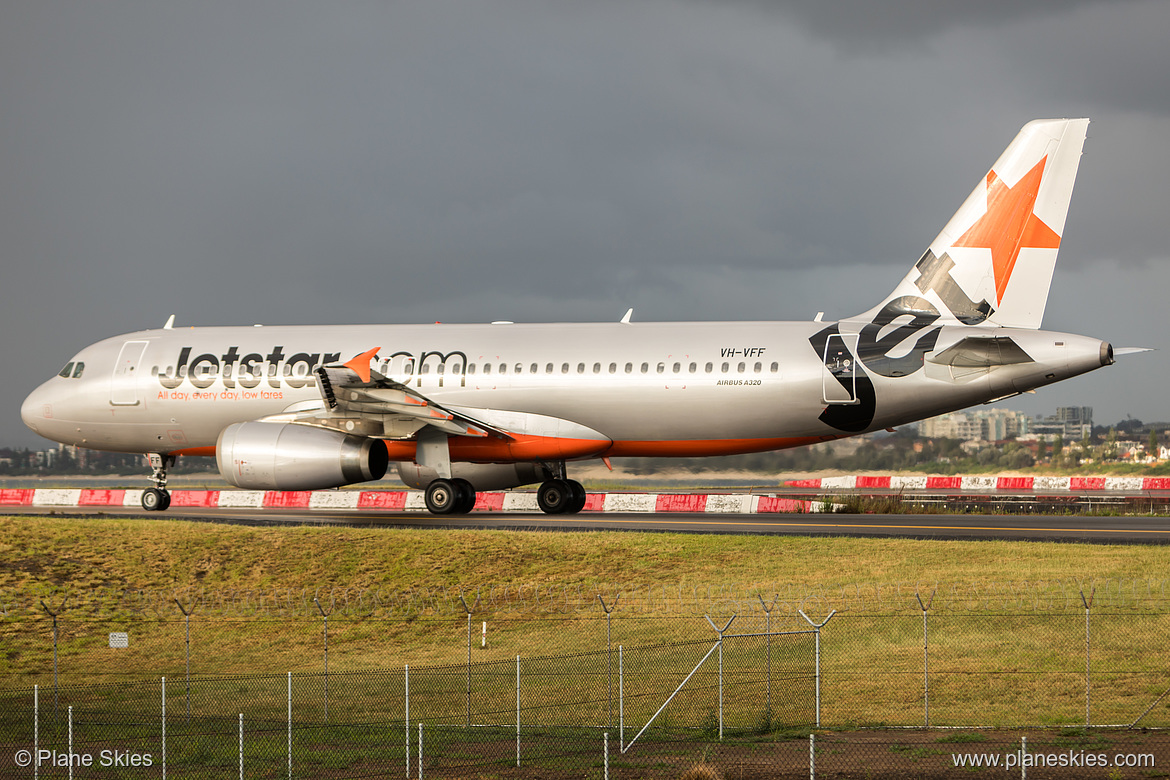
[0,578,1170,621]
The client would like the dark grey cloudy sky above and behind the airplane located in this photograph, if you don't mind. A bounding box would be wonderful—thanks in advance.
[0,0,1170,446]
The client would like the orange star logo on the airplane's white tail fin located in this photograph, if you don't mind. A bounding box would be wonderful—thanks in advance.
[954,157,1060,303]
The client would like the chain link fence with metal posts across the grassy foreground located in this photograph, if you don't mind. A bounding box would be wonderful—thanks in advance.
[0,580,1170,778]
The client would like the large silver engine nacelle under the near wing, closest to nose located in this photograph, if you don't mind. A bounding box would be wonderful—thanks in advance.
[215,422,390,490]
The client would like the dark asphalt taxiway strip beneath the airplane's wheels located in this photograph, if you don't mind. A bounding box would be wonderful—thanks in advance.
[9,506,1170,544]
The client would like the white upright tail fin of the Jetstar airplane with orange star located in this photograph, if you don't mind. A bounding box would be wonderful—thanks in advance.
[861,119,1089,329]
